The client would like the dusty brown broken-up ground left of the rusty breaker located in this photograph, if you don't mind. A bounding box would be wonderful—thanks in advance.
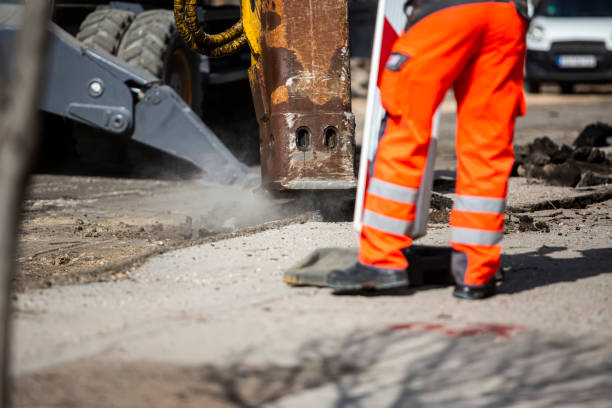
[15,175,312,291]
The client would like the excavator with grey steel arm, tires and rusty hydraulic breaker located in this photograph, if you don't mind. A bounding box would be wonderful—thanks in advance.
[0,0,378,191]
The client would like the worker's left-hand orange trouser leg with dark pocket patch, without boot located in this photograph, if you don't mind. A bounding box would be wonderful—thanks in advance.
[359,4,486,270]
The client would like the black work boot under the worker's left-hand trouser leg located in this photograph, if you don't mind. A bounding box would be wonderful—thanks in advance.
[325,262,409,290]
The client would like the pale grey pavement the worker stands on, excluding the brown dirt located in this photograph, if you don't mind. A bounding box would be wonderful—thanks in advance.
[9,188,612,407]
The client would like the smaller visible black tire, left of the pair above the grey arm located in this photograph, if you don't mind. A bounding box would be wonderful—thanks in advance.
[76,8,136,55]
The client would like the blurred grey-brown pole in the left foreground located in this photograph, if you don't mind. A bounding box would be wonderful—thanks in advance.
[0,0,52,407]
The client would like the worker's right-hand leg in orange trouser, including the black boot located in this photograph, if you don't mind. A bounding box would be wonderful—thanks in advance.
[450,3,525,298]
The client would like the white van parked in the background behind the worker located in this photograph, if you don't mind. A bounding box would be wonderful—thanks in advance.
[525,0,612,93]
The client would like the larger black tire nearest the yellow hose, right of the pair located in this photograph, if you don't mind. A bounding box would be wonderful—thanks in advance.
[117,10,202,115]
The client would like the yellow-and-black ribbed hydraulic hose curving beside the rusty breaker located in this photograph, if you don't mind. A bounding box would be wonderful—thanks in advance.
[174,0,247,57]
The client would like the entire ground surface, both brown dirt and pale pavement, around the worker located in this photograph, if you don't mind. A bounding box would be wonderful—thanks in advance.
[13,82,612,407]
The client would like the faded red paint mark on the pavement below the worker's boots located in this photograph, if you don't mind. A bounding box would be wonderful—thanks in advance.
[389,322,524,339]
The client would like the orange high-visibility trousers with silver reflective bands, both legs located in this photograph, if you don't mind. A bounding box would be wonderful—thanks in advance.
[359,2,526,286]
